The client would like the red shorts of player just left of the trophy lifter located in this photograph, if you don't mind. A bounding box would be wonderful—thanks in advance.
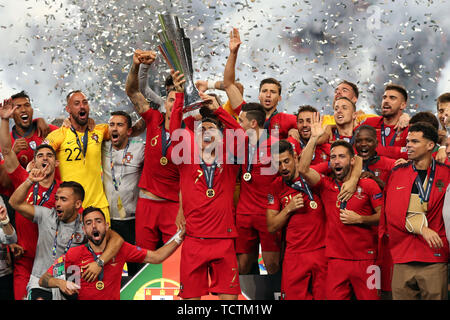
[136,198,179,250]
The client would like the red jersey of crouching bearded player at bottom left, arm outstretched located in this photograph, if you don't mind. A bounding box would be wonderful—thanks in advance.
[47,242,147,300]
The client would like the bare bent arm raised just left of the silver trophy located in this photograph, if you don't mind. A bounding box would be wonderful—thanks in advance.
[125,50,150,114]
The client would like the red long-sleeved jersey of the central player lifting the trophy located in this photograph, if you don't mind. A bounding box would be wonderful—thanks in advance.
[170,93,239,238]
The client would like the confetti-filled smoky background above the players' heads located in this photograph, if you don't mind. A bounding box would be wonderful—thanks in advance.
[0,0,450,121]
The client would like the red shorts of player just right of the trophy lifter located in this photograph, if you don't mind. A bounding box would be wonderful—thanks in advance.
[236,214,281,253]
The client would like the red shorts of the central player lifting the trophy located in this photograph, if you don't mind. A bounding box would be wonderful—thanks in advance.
[179,236,241,299]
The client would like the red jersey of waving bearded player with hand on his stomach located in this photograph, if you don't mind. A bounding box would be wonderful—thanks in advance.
[316,175,383,260]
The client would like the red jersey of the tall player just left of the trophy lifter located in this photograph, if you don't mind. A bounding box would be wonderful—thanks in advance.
[138,109,180,202]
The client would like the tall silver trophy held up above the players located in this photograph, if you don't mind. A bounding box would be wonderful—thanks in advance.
[158,14,202,116]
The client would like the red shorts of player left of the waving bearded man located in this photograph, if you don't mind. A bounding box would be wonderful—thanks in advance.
[281,248,328,300]
